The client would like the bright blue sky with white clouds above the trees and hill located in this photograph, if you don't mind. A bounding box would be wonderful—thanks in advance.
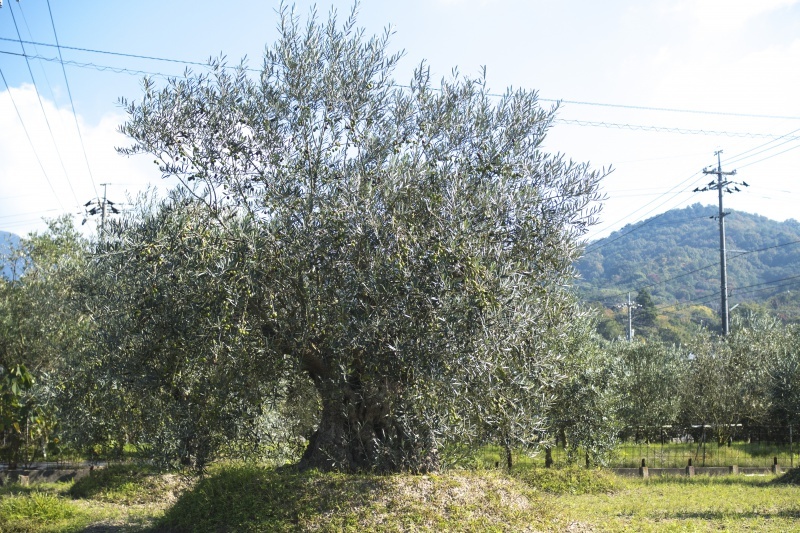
[0,0,800,240]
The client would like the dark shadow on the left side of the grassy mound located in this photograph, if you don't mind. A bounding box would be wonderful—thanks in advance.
[154,465,385,532]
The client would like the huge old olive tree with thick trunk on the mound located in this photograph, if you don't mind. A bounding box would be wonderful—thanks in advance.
[114,4,602,471]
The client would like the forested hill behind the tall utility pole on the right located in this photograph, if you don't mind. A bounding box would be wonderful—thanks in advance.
[576,204,800,307]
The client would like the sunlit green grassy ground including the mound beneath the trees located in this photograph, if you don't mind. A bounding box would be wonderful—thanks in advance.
[0,465,800,533]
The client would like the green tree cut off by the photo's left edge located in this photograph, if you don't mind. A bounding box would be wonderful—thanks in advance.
[0,217,87,464]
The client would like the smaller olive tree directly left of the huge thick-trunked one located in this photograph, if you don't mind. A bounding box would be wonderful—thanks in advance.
[62,191,290,469]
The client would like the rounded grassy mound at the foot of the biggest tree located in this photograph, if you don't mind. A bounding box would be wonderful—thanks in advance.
[161,466,549,531]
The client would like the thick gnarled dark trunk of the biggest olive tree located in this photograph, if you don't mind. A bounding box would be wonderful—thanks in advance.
[298,377,439,472]
